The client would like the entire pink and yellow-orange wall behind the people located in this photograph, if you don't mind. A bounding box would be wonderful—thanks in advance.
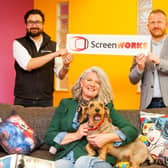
[0,0,168,109]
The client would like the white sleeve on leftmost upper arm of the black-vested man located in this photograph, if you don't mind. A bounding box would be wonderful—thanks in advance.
[13,40,31,70]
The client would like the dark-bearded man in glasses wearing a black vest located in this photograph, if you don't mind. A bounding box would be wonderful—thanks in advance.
[13,9,72,106]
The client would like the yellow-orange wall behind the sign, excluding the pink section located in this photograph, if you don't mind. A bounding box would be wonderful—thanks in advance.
[34,0,168,109]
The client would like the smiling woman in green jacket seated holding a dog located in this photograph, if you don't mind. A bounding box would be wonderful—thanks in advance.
[45,67,138,168]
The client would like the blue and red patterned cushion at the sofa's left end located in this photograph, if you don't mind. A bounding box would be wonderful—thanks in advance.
[0,113,40,154]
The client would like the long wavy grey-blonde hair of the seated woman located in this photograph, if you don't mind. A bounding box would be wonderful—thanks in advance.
[71,66,113,104]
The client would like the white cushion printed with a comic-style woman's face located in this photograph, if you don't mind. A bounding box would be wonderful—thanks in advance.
[140,111,168,166]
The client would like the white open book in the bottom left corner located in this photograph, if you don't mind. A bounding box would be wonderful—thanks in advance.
[0,154,54,168]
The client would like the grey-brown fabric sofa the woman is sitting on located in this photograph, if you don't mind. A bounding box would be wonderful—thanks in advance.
[0,103,168,168]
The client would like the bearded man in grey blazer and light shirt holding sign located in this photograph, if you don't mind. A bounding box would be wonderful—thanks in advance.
[129,9,168,109]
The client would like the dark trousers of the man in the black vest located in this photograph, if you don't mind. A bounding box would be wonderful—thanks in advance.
[14,97,53,107]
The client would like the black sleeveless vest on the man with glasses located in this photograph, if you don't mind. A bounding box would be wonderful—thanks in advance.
[14,33,56,100]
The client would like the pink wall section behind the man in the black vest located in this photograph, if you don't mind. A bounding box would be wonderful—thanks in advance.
[0,0,33,104]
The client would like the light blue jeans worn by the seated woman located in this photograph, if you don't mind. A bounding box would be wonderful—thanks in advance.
[55,156,113,168]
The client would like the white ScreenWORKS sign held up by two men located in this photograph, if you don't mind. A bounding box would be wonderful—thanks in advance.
[67,34,151,55]
